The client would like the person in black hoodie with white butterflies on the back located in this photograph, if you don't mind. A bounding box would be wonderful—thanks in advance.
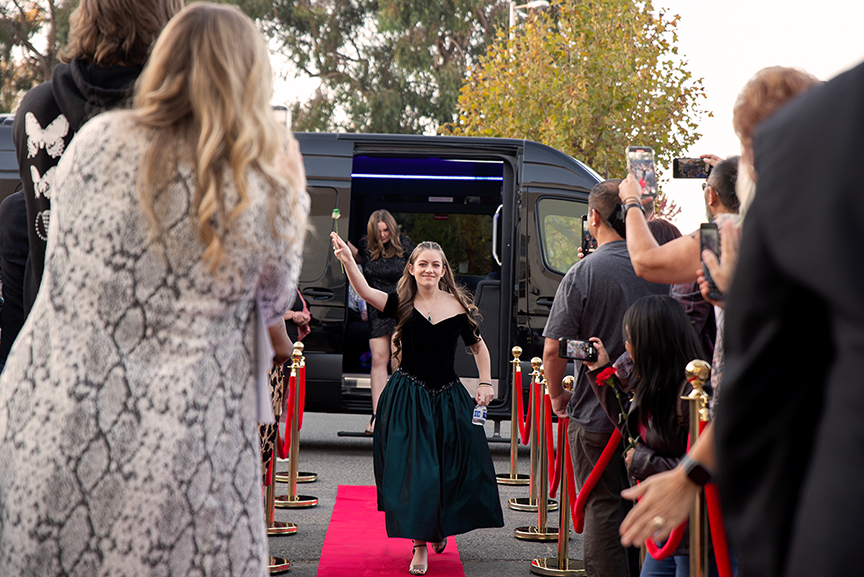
[12,0,183,318]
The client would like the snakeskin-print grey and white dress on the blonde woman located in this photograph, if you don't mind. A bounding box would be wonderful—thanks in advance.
[0,113,308,577]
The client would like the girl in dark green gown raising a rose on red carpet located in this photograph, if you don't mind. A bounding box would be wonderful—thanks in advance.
[330,233,504,575]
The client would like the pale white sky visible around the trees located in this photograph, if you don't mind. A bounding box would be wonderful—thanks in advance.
[273,0,864,234]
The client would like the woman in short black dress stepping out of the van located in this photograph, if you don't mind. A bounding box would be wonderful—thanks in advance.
[348,209,414,435]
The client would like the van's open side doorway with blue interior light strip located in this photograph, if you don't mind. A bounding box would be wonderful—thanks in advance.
[351,140,518,418]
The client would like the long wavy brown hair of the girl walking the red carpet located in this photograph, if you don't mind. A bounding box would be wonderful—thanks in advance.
[390,241,480,364]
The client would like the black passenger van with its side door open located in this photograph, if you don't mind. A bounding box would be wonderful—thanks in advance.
[296,133,601,421]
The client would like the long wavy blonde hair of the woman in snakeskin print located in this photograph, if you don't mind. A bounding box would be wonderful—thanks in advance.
[132,2,306,274]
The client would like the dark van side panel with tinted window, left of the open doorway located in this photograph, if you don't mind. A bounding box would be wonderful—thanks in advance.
[297,133,354,413]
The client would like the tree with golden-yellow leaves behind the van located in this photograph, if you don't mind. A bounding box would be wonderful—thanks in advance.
[445,0,705,214]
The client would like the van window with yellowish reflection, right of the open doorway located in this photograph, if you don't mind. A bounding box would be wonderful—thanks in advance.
[537,197,588,275]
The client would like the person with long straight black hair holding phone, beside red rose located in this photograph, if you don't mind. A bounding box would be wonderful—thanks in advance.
[584,295,705,577]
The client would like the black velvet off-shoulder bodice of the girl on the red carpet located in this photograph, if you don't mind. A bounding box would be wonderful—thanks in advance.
[381,293,479,392]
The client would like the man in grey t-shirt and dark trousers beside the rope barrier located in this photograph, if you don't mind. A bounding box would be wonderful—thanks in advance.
[543,180,669,577]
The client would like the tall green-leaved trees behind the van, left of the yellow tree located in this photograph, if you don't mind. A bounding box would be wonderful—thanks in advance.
[235,0,507,133]
